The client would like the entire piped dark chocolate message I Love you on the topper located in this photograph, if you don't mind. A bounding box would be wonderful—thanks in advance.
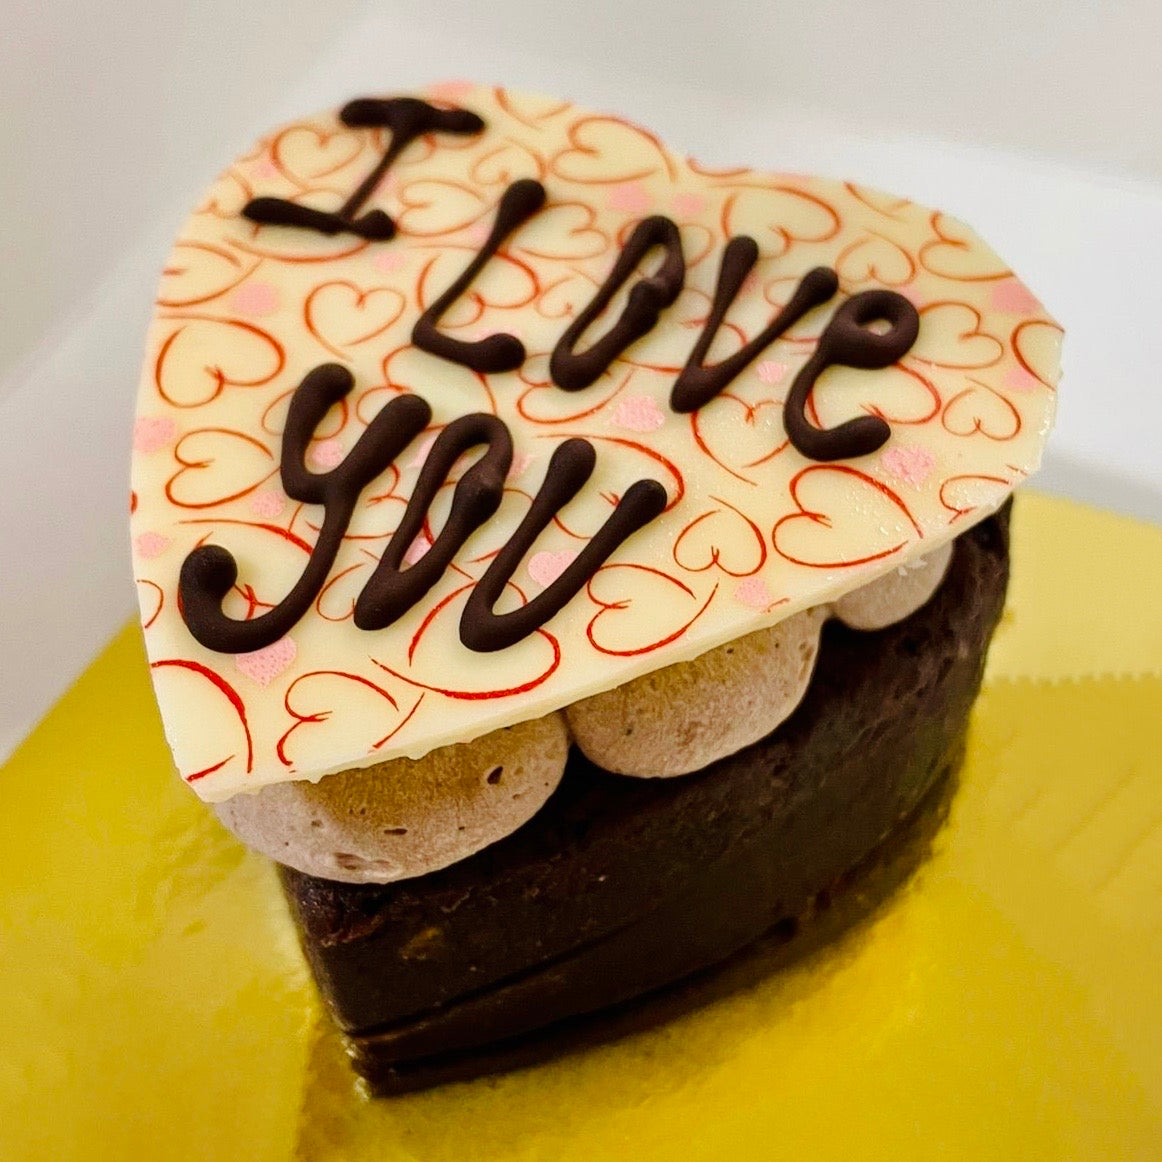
[179,98,919,653]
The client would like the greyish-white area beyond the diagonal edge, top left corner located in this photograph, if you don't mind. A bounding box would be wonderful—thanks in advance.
[0,0,359,378]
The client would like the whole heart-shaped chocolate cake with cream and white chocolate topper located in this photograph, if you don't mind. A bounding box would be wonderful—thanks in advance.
[132,83,1061,1090]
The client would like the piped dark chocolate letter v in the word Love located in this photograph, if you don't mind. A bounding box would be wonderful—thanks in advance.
[669,235,839,413]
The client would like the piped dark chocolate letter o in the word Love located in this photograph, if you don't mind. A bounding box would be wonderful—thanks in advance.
[548,215,686,392]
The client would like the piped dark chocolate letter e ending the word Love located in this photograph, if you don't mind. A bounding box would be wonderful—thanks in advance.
[783,291,920,460]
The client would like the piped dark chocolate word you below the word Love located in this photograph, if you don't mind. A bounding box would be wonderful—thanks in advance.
[178,364,666,653]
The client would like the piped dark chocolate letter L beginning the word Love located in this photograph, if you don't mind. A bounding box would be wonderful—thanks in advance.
[411,178,545,374]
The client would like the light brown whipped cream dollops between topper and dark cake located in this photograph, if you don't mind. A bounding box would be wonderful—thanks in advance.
[215,545,952,883]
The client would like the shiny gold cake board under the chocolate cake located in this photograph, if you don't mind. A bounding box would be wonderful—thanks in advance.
[0,493,1162,1162]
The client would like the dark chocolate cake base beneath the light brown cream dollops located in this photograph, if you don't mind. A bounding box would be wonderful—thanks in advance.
[282,508,1007,1093]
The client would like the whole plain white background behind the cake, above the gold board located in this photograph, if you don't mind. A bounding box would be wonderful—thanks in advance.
[0,0,1162,759]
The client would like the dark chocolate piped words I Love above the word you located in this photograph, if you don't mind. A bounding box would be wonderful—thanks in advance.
[243,98,919,460]
